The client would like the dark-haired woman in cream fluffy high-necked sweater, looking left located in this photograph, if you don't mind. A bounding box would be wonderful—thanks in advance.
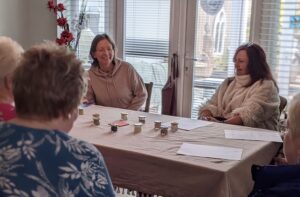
[199,43,280,130]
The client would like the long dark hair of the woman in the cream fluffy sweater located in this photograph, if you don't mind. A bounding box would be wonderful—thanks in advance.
[233,42,278,90]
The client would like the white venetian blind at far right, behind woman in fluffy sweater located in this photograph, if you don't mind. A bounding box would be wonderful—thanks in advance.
[259,0,300,104]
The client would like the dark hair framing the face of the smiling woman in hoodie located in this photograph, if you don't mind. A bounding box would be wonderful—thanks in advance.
[90,34,116,66]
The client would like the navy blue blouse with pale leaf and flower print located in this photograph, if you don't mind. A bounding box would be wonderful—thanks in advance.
[0,123,115,197]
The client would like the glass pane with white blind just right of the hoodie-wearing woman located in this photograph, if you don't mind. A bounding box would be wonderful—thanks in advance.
[124,0,170,113]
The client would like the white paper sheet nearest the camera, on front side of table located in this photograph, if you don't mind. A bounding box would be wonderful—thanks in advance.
[177,143,243,160]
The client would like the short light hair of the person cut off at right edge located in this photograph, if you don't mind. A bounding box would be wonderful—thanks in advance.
[288,94,300,137]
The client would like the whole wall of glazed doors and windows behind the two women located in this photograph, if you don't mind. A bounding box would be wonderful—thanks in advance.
[59,0,300,118]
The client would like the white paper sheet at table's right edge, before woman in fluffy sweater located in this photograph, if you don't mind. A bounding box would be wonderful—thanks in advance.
[224,130,282,142]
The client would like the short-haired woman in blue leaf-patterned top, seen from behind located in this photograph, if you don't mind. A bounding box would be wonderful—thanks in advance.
[0,42,115,196]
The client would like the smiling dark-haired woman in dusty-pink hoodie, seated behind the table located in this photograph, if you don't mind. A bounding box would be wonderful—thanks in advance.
[86,34,147,110]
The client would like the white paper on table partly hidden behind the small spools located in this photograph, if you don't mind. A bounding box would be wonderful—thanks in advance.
[163,118,212,131]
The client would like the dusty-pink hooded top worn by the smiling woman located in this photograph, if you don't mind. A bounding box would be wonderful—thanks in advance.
[86,59,147,110]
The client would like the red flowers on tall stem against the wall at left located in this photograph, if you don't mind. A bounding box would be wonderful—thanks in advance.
[48,0,74,47]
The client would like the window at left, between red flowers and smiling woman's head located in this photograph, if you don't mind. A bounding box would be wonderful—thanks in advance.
[58,0,114,69]
